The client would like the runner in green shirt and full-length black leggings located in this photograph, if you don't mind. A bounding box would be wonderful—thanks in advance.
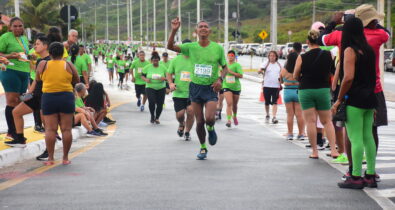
[141,52,167,124]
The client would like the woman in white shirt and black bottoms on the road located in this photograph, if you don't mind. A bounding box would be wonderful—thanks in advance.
[258,51,282,124]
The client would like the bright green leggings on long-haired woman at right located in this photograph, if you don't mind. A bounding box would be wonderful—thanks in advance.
[346,106,376,176]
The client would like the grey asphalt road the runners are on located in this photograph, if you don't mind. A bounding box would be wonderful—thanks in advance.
[0,61,380,209]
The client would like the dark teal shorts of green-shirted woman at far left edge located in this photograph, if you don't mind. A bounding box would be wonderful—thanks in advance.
[0,69,30,94]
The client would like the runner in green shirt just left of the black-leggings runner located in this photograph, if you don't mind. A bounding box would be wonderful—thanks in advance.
[130,51,150,111]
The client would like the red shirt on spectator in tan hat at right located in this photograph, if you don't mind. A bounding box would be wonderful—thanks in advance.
[322,28,389,93]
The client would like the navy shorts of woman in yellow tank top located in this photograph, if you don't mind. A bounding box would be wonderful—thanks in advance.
[41,92,75,115]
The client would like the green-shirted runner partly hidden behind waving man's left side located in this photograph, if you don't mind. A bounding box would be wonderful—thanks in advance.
[167,40,194,141]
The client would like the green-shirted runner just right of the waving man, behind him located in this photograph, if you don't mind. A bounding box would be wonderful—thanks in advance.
[222,50,243,127]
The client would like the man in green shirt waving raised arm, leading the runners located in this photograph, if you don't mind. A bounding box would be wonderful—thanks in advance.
[167,17,228,160]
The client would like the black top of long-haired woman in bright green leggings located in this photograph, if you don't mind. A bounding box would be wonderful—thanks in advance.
[346,47,377,109]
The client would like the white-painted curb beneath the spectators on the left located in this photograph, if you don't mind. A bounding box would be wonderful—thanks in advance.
[0,127,86,168]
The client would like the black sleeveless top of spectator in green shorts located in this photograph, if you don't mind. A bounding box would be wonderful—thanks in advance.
[299,48,334,89]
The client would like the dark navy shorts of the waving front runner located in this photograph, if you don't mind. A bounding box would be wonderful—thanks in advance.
[189,82,218,104]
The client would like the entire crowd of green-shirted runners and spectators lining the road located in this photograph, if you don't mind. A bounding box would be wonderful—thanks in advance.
[0,5,390,189]
